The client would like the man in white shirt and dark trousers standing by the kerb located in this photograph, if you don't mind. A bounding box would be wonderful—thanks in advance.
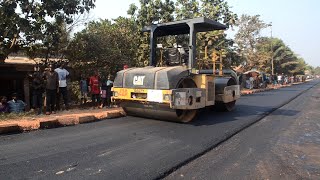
[54,63,69,110]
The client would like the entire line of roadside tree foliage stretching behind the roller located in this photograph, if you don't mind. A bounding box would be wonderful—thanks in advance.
[0,0,316,74]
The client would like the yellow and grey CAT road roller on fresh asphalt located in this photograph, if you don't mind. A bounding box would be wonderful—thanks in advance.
[112,17,240,122]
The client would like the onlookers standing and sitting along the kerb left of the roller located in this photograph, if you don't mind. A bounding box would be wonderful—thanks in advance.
[0,63,128,115]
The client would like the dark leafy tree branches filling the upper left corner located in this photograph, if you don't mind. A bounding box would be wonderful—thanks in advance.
[0,0,95,60]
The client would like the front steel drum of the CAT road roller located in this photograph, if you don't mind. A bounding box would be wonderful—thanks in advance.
[120,102,197,123]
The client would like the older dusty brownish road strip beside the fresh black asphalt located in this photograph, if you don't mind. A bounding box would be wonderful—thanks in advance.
[166,82,320,180]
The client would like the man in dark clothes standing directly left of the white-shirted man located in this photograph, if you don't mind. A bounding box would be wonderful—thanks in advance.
[44,65,59,115]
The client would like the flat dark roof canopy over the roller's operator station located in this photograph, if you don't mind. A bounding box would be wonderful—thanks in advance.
[142,17,227,37]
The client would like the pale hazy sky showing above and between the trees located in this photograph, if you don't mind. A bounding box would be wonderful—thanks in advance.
[91,0,320,67]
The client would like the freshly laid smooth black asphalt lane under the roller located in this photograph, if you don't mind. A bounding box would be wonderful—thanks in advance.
[0,81,319,179]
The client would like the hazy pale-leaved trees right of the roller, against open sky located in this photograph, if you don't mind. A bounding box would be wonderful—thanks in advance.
[235,15,307,75]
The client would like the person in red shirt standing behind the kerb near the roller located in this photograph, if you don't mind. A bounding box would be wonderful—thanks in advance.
[89,71,100,107]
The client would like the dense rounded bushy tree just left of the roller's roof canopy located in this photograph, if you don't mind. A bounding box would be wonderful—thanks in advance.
[67,17,139,76]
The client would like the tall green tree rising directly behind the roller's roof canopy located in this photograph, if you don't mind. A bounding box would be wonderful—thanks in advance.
[128,0,237,65]
